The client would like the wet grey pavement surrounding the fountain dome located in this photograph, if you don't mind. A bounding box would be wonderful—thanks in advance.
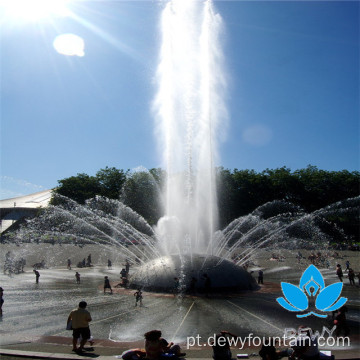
[0,248,360,359]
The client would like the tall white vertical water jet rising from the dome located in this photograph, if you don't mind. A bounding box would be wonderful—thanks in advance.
[154,0,227,255]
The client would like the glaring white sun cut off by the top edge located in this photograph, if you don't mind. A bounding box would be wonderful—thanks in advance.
[0,0,70,21]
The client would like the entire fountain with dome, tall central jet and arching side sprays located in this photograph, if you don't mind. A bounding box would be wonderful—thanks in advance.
[3,0,359,291]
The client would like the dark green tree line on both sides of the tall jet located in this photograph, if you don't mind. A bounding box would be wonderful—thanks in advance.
[52,165,360,242]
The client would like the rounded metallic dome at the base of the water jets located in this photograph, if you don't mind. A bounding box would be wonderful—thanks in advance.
[130,254,258,293]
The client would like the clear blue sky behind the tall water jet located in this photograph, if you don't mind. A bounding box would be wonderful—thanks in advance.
[0,0,359,199]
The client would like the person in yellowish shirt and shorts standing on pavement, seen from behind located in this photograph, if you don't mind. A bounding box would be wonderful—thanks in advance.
[67,301,92,351]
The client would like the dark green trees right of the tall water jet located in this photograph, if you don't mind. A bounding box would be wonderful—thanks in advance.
[218,165,360,224]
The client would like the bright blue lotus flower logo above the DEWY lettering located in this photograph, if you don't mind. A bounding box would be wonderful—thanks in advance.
[276,265,347,318]
